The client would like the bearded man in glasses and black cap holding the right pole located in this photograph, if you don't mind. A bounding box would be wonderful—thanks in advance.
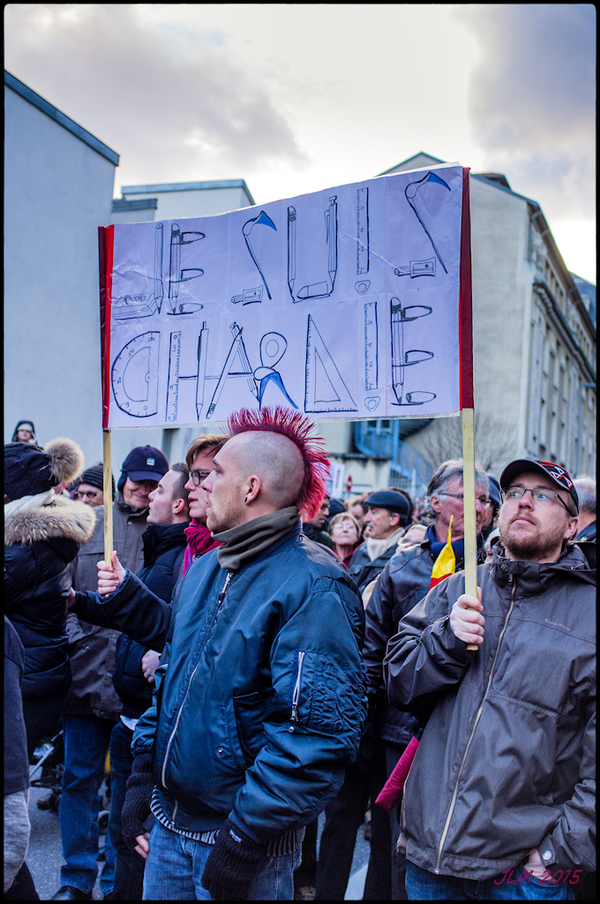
[384,459,595,900]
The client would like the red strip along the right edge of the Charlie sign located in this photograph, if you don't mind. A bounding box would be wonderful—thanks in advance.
[458,166,474,411]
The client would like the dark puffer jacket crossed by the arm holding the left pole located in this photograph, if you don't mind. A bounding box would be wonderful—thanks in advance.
[113,522,187,719]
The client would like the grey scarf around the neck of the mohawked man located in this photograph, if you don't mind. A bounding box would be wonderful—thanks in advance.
[213,505,300,571]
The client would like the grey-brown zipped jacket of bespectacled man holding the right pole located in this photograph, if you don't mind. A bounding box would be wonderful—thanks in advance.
[384,546,596,879]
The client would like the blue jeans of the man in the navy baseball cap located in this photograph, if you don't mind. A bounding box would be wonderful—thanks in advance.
[58,715,115,895]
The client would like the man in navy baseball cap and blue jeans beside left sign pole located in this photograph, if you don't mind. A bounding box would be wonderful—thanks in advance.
[52,446,169,901]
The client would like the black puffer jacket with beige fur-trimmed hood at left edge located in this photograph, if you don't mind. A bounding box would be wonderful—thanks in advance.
[4,496,95,698]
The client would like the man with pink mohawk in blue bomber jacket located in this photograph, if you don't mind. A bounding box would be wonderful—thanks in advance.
[123,408,366,900]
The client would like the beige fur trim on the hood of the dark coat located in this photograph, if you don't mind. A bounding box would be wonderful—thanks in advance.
[4,496,96,546]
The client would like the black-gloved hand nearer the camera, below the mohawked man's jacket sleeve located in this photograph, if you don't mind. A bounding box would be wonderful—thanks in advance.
[202,819,266,901]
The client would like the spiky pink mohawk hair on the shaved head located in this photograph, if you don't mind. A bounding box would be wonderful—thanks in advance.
[227,405,330,521]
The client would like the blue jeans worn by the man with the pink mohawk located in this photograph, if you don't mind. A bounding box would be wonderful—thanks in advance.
[143,822,302,901]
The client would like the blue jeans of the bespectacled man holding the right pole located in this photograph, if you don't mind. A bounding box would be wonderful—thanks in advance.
[406,861,575,901]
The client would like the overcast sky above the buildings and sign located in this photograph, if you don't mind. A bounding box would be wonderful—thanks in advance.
[5,3,596,283]
